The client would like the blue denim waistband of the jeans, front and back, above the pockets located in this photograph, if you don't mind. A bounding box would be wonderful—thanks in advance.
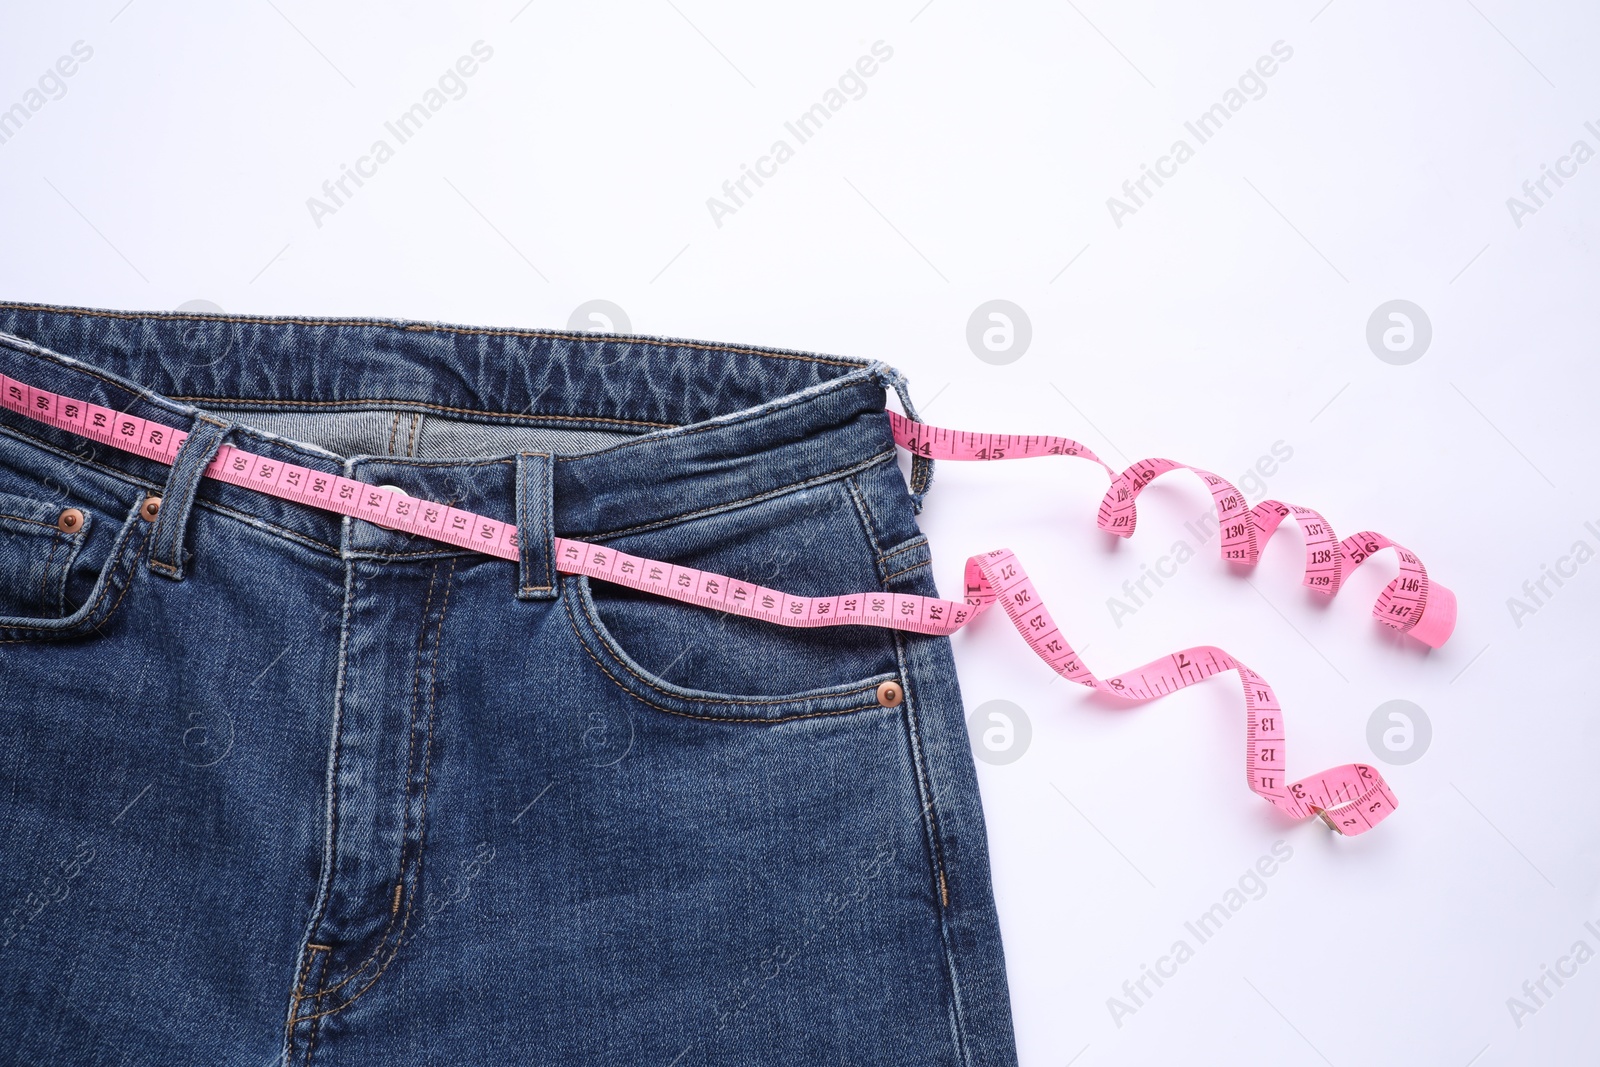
[0,304,902,552]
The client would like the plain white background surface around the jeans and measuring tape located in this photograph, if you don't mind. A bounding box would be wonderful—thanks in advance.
[0,0,1600,1067]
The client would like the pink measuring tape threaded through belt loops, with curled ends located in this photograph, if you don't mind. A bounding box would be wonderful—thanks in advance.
[0,374,1456,837]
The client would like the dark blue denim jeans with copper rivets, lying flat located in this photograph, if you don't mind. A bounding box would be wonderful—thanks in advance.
[0,304,1014,1067]
